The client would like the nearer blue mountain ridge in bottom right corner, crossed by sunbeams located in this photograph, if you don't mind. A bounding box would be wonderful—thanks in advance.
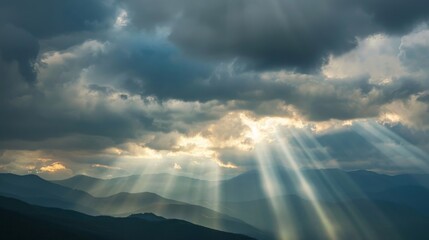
[220,195,429,240]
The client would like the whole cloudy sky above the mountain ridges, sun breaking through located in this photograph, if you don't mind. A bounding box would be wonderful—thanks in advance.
[0,0,429,179]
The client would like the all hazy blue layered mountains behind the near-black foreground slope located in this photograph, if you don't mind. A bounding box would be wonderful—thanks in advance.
[0,169,429,239]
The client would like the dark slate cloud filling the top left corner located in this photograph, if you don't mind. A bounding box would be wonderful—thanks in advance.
[0,0,116,83]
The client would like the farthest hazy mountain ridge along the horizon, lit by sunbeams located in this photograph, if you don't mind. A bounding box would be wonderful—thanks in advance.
[55,168,429,202]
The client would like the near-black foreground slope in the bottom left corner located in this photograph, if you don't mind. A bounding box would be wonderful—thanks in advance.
[0,197,251,239]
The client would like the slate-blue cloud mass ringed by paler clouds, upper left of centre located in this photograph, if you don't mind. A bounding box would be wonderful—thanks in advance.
[78,32,213,100]
